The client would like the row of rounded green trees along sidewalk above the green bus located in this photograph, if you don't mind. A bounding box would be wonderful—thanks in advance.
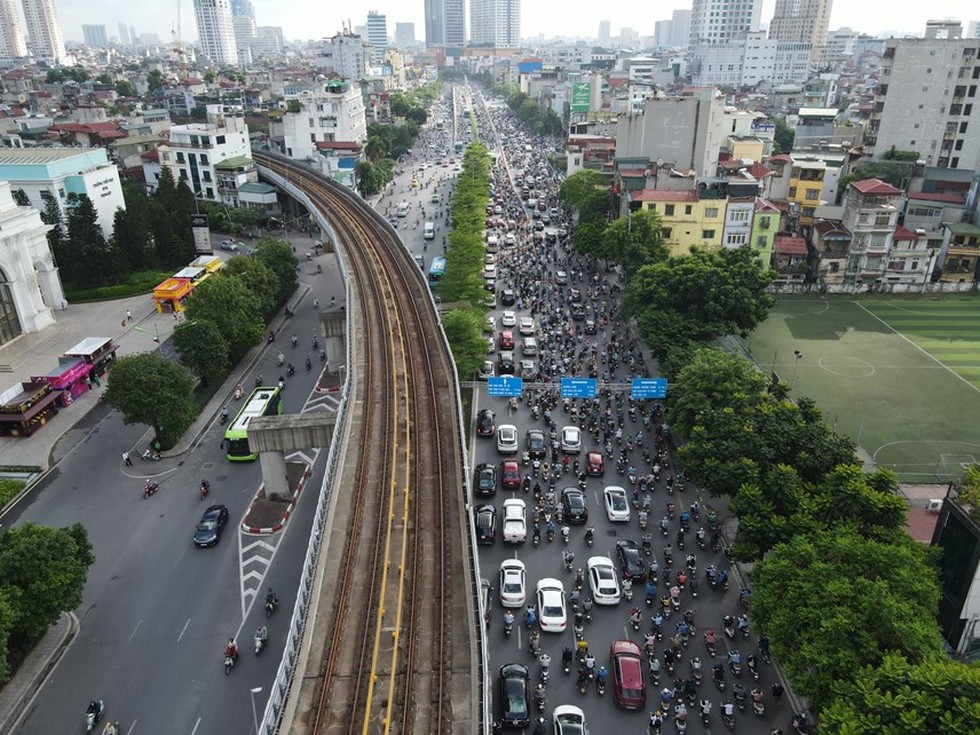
[105,238,298,449]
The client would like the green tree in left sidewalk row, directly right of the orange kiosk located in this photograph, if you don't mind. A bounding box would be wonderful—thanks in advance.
[184,276,265,362]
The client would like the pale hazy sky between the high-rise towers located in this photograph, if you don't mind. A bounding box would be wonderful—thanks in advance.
[55,0,980,42]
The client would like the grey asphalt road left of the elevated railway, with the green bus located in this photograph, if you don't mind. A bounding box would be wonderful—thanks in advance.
[5,248,340,735]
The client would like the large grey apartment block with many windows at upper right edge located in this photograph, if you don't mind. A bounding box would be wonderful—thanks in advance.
[865,38,980,171]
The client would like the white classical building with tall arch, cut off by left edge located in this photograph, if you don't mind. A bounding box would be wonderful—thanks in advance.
[0,181,67,344]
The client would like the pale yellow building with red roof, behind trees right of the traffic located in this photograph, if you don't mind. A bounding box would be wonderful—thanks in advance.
[631,189,726,256]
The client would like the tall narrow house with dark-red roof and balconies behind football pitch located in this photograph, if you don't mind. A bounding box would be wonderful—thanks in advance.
[841,179,902,286]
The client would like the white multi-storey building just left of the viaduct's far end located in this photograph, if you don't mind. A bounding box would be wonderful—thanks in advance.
[161,106,254,206]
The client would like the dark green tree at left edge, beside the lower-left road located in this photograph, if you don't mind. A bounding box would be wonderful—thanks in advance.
[0,523,95,643]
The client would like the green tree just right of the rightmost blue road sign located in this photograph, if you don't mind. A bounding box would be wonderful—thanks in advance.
[667,347,768,438]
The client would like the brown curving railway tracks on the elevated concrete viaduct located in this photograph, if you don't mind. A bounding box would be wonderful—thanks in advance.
[258,154,475,735]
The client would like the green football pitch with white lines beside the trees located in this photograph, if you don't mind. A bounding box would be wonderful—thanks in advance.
[743,294,980,482]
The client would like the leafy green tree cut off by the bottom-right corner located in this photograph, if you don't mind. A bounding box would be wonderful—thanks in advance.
[820,654,980,735]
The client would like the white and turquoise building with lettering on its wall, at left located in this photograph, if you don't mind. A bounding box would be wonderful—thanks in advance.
[0,148,126,239]
